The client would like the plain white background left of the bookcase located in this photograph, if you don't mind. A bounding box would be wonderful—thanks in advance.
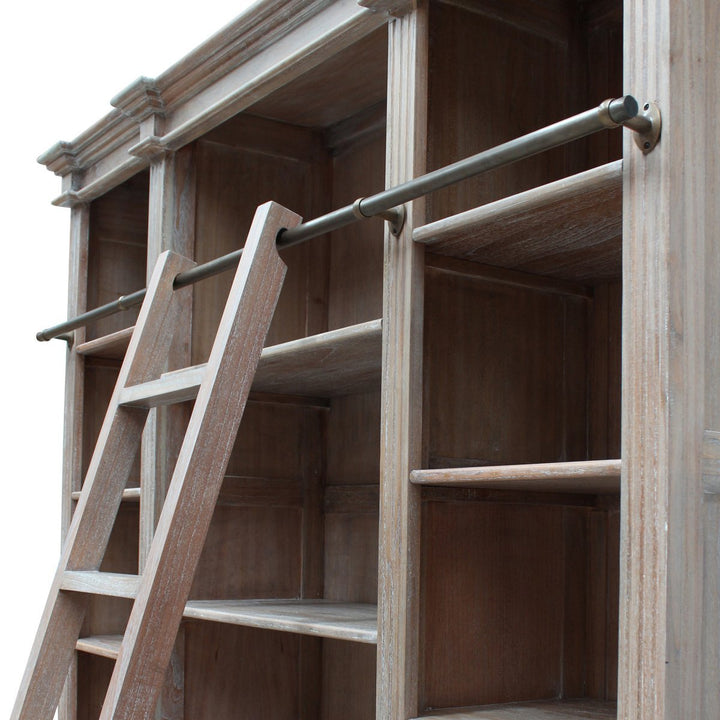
[0,0,250,719]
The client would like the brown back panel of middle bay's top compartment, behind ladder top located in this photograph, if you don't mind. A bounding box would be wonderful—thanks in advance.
[188,137,329,363]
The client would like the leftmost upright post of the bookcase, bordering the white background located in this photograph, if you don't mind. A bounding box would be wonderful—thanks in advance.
[58,204,90,720]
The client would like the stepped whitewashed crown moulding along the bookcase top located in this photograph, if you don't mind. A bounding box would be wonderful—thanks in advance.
[39,0,387,206]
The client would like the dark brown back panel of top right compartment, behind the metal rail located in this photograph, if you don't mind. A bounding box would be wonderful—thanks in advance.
[427,2,572,221]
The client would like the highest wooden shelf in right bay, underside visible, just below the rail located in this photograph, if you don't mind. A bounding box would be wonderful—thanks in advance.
[413,160,622,282]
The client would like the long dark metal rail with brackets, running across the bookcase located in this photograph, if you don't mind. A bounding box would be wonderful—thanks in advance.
[36,95,660,341]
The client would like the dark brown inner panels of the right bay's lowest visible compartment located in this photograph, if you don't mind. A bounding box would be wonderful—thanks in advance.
[421,495,619,708]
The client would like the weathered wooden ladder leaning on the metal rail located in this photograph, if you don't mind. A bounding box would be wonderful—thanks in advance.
[11,202,300,720]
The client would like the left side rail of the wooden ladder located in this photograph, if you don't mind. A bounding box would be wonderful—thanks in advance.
[11,253,191,720]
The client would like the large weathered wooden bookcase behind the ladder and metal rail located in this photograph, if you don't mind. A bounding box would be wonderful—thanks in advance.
[25,0,720,720]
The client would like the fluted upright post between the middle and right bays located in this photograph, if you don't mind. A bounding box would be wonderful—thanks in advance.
[376,2,428,720]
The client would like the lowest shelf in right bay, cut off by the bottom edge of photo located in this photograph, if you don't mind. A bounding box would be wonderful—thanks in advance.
[422,699,617,720]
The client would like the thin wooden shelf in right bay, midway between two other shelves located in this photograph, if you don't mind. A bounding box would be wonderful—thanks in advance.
[410,460,621,493]
